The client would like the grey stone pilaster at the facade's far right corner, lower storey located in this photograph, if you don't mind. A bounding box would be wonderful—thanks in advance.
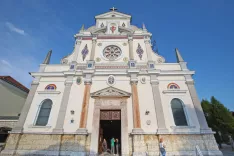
[186,76,212,133]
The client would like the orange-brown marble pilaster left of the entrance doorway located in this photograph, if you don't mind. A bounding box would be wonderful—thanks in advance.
[77,80,92,134]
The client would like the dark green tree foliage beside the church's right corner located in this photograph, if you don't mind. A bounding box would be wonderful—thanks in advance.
[201,96,234,143]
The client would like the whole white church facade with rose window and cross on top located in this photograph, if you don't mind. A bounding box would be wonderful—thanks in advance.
[1,8,222,156]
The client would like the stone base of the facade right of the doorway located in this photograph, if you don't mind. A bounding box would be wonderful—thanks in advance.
[129,134,222,156]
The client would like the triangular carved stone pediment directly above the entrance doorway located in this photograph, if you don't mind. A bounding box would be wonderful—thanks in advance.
[91,87,131,97]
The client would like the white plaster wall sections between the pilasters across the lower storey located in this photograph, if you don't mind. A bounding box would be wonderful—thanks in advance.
[21,71,200,133]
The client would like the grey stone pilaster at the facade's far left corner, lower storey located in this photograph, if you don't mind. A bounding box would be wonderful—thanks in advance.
[12,78,40,133]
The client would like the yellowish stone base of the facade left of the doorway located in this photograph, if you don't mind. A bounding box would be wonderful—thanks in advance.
[1,134,90,156]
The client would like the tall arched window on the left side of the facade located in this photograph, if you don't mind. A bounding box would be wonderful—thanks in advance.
[36,99,52,126]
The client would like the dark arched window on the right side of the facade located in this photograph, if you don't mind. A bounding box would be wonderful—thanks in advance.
[171,99,188,126]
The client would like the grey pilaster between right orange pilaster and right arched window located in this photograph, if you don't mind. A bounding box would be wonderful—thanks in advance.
[151,75,168,134]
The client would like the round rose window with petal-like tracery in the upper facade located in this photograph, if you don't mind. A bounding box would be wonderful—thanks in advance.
[103,45,122,61]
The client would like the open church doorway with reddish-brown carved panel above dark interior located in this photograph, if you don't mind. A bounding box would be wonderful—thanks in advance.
[98,110,121,154]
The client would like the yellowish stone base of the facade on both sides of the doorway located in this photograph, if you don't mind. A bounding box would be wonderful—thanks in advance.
[0,134,222,156]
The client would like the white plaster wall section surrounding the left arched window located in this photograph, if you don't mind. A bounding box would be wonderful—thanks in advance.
[24,77,65,132]
